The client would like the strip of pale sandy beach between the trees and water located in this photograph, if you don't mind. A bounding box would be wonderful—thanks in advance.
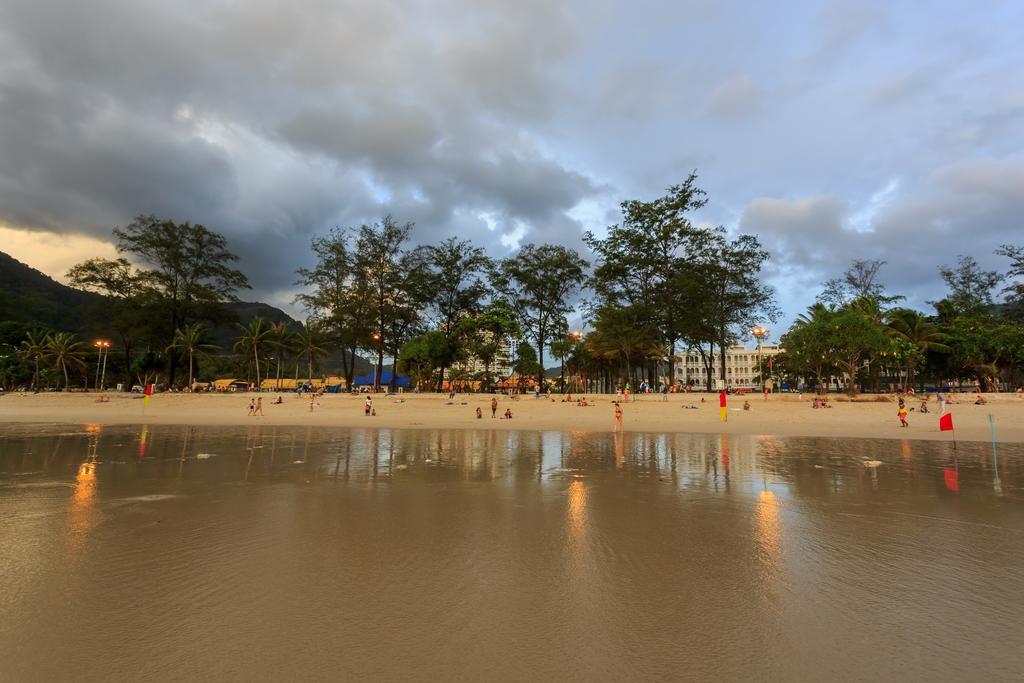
[0,393,1024,442]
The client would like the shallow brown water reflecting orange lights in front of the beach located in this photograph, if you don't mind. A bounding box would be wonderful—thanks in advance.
[0,425,1024,680]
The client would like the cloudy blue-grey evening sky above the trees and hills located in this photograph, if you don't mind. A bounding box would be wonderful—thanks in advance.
[0,0,1024,332]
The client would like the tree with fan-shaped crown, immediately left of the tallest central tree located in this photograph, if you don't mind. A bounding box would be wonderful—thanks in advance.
[494,245,589,386]
